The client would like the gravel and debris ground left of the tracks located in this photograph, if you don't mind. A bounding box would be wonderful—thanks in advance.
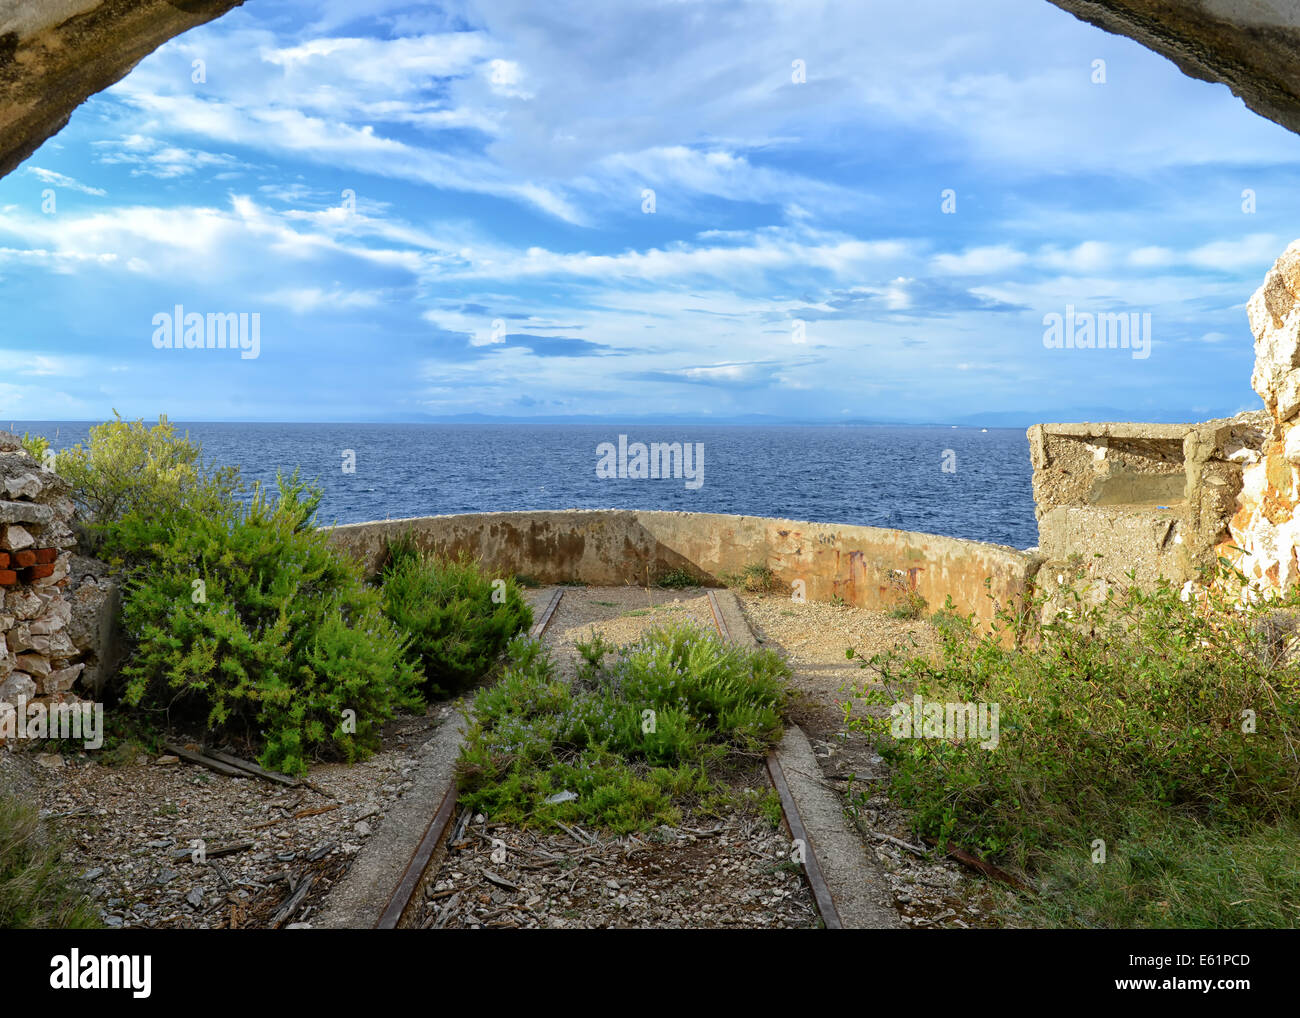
[0,705,451,928]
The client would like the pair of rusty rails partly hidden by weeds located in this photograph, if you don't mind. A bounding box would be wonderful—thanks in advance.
[374,588,842,930]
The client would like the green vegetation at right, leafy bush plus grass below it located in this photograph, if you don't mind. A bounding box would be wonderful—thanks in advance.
[849,572,1300,928]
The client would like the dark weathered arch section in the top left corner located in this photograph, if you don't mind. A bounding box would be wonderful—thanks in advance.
[0,0,243,177]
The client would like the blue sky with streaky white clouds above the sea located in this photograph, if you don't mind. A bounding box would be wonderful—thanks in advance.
[0,0,1300,424]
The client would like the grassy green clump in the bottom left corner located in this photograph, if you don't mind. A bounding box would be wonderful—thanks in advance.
[0,796,100,930]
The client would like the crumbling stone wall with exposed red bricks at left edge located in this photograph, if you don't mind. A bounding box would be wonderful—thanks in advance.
[0,432,116,744]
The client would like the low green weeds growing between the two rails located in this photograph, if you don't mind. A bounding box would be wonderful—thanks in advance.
[458,625,789,833]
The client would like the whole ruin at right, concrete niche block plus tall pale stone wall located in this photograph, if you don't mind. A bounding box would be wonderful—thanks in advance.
[1028,241,1300,590]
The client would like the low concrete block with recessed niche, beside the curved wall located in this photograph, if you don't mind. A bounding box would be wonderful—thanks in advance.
[1028,411,1271,586]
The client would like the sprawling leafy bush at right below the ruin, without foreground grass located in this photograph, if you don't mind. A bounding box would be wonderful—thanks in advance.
[854,569,1300,914]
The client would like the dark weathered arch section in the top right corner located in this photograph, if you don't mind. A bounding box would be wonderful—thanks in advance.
[1050,0,1300,131]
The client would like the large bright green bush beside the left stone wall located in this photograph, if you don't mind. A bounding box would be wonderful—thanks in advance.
[108,475,419,774]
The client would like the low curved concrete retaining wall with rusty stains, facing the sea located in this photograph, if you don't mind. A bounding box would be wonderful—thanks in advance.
[329,510,1041,623]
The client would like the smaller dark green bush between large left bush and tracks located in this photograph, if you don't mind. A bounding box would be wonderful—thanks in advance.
[384,540,533,696]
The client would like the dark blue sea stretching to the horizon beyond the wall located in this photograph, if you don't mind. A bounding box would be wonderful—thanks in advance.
[10,421,1037,547]
